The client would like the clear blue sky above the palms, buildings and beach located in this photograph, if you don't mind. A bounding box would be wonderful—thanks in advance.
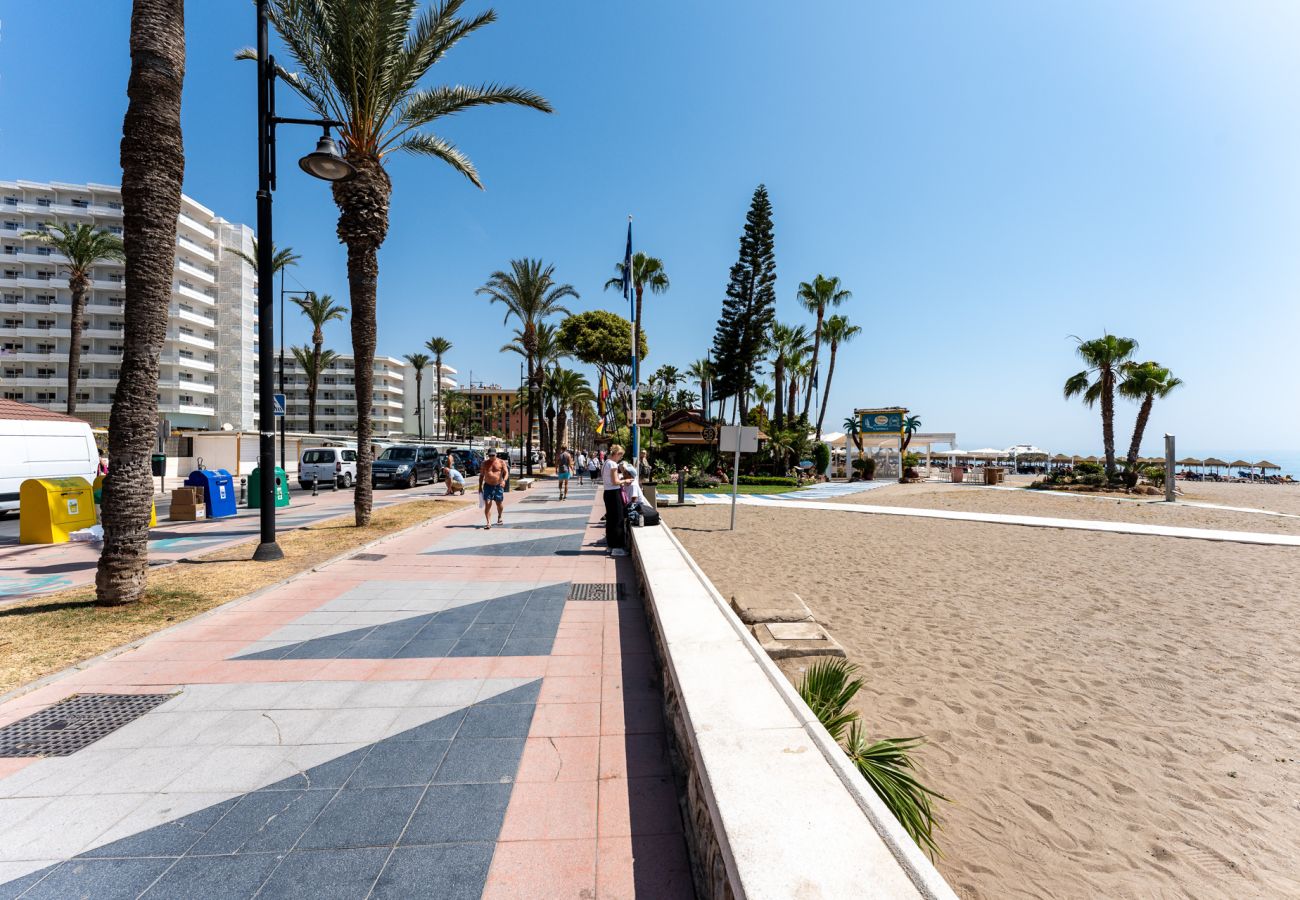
[0,0,1300,455]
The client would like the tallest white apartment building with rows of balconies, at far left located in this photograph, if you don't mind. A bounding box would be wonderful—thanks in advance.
[0,181,256,429]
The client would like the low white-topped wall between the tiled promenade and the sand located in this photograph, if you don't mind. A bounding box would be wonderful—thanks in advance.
[631,525,957,900]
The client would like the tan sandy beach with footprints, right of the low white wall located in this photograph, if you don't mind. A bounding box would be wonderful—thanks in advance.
[666,485,1300,899]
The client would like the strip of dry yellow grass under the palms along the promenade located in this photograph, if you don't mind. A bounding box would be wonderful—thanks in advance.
[0,499,469,693]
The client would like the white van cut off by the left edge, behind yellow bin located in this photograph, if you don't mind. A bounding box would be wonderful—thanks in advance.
[0,401,99,516]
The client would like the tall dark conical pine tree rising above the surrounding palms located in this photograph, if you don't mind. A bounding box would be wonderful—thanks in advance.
[714,185,776,407]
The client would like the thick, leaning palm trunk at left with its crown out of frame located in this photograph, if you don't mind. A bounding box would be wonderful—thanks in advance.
[95,0,185,605]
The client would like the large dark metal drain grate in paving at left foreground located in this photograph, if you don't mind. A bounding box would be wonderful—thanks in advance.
[0,693,176,757]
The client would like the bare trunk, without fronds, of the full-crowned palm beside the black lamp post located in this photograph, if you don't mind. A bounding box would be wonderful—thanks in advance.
[334,156,393,527]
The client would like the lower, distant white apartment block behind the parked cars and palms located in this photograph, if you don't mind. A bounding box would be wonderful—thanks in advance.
[254,354,456,437]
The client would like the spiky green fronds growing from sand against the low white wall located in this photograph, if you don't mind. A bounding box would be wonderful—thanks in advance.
[800,659,948,857]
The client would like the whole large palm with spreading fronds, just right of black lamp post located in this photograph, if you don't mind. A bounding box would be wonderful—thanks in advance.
[256,0,551,525]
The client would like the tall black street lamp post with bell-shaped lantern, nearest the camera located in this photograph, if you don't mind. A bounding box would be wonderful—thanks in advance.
[252,0,355,562]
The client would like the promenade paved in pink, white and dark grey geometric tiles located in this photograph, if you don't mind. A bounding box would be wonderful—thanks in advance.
[0,484,693,899]
